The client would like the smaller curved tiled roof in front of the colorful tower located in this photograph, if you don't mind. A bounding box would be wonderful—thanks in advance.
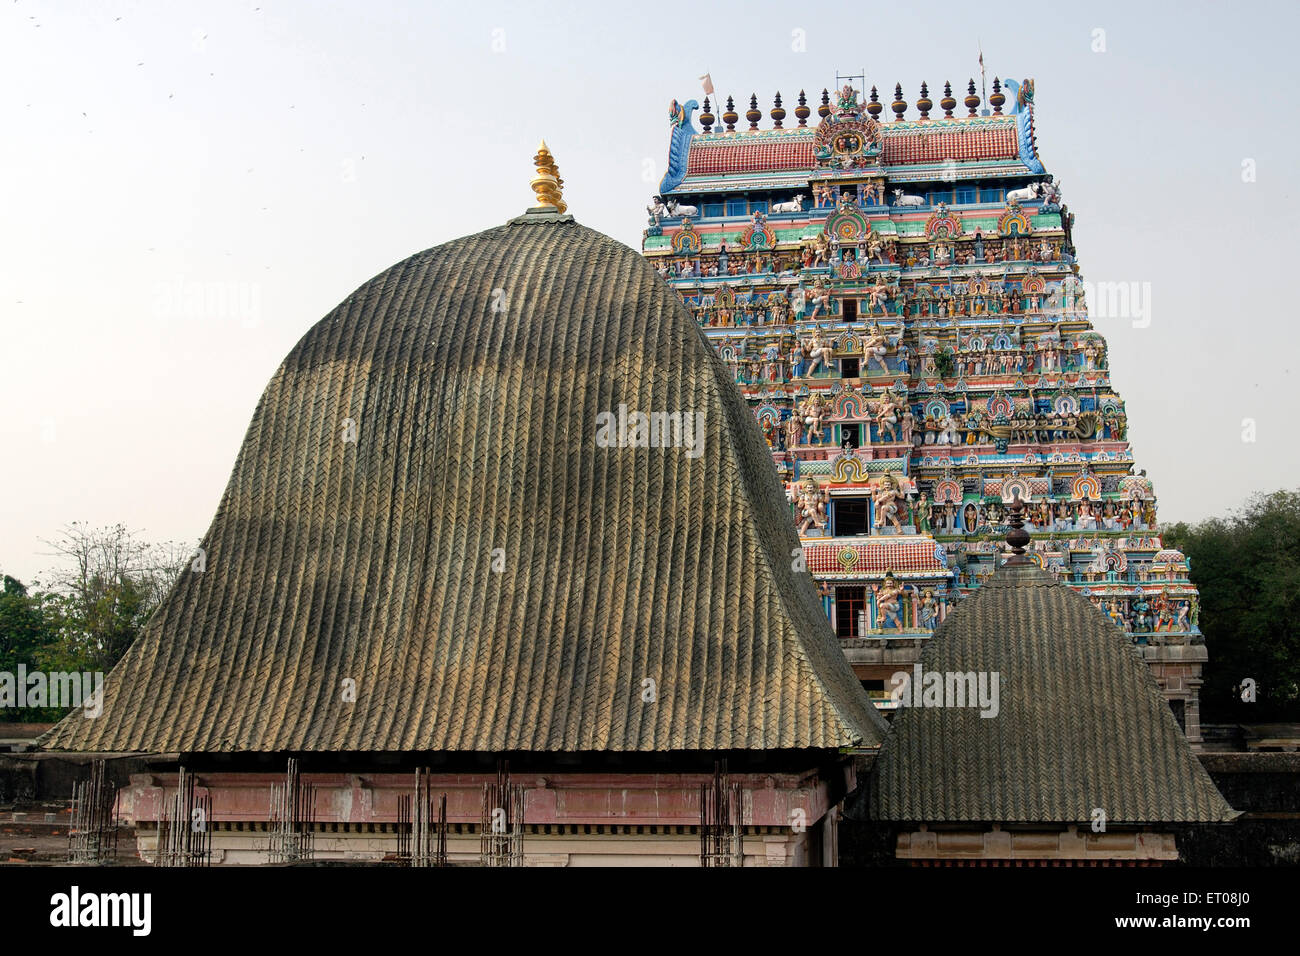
[870,566,1238,826]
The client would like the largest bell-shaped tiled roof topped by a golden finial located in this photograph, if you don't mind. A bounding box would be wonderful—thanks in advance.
[43,213,883,752]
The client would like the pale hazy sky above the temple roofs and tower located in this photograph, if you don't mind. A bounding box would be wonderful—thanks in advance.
[0,0,1300,580]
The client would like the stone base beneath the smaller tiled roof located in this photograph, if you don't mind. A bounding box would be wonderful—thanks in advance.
[894,826,1178,864]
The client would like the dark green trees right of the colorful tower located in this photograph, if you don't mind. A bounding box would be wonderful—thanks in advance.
[1164,490,1300,723]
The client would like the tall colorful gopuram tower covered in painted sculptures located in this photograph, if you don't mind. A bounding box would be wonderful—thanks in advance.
[644,79,1205,744]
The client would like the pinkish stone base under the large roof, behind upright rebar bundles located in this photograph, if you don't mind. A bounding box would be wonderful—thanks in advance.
[118,756,857,866]
